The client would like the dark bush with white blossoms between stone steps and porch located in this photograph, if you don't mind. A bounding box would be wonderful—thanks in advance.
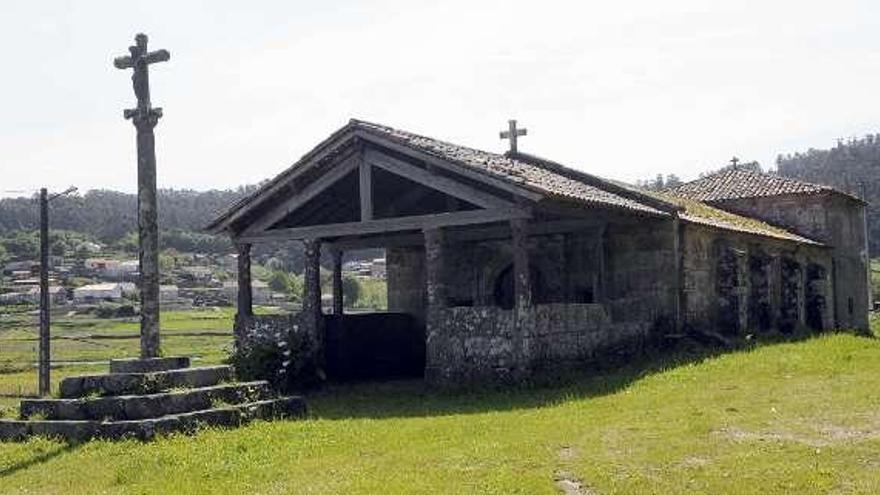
[227,323,324,392]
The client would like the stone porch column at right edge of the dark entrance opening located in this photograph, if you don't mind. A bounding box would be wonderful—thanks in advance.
[425,229,446,386]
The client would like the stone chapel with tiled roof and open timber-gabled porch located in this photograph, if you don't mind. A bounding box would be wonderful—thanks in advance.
[208,120,870,385]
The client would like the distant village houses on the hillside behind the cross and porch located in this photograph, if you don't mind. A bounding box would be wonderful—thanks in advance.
[0,243,385,316]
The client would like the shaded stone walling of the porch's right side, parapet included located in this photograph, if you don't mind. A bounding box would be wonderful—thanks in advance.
[426,221,675,385]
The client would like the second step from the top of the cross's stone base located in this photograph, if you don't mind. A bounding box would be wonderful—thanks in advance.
[60,365,232,399]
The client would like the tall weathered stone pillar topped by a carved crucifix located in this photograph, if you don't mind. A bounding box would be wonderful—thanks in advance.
[113,33,171,358]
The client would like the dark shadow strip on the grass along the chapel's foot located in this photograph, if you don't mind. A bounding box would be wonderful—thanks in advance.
[307,331,875,420]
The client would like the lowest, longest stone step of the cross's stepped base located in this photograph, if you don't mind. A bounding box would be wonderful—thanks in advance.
[0,397,306,442]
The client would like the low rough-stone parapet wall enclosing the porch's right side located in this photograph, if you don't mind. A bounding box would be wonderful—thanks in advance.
[425,303,648,386]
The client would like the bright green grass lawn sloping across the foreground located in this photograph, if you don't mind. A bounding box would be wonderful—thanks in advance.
[0,318,880,494]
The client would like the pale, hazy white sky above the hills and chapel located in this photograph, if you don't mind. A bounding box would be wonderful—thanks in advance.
[0,0,880,197]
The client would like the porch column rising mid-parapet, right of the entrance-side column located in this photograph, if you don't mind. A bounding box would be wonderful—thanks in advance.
[510,219,532,375]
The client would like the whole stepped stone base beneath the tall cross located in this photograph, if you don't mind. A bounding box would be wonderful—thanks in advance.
[0,357,306,442]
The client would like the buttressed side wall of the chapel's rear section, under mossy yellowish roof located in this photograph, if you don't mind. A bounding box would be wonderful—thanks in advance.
[682,224,834,335]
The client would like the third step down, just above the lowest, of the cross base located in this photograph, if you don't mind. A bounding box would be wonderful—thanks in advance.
[20,381,271,420]
